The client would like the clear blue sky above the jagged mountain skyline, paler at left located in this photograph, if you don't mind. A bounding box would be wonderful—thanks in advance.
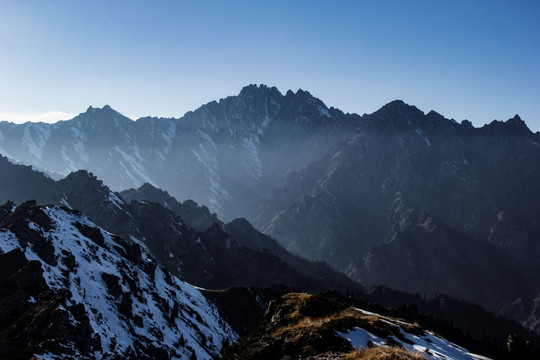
[0,0,540,131]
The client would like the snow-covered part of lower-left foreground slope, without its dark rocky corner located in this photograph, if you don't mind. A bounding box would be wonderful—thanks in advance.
[0,203,236,359]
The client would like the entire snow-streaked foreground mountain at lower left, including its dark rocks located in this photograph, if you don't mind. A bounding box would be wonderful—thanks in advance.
[0,202,237,359]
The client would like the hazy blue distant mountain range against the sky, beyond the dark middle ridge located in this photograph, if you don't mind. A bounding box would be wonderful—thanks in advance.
[0,85,540,320]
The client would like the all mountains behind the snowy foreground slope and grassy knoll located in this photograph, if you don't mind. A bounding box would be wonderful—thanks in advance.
[0,85,540,353]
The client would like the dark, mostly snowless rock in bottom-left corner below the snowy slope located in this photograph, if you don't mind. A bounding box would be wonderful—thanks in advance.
[0,249,101,359]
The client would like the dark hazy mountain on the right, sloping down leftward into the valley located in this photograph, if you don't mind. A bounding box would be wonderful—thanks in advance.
[254,101,540,311]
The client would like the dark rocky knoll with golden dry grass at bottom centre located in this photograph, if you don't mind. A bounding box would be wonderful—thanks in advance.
[224,293,434,360]
